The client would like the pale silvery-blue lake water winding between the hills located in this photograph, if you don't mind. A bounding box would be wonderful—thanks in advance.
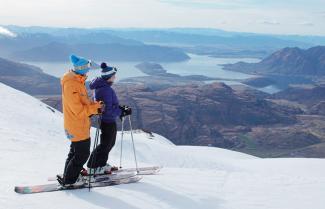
[27,54,277,93]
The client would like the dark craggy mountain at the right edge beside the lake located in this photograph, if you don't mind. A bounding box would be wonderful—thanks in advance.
[224,46,325,89]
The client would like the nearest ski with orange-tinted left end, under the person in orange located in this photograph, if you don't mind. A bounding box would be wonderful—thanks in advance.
[15,175,142,194]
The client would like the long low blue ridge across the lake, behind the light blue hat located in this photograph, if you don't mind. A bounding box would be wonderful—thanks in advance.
[11,42,189,62]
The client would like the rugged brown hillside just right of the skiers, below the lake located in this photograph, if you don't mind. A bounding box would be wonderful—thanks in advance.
[116,83,296,145]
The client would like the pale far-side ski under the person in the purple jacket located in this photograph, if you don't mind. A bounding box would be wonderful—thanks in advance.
[47,166,162,181]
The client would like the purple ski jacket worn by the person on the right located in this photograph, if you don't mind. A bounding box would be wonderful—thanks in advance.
[89,77,121,123]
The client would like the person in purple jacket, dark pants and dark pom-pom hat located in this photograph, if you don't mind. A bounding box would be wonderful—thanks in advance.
[87,62,132,174]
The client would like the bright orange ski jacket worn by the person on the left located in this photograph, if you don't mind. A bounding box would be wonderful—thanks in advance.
[61,71,101,142]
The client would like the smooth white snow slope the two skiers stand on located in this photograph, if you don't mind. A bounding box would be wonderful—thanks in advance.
[0,83,325,209]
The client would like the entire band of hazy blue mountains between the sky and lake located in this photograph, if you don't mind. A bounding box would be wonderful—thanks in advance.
[0,25,325,62]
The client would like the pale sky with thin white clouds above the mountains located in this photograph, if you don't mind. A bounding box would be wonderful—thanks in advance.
[0,0,325,35]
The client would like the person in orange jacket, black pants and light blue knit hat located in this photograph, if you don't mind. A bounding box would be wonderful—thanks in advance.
[58,55,102,186]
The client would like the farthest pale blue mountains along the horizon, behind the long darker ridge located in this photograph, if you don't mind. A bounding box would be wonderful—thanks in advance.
[0,25,325,62]
